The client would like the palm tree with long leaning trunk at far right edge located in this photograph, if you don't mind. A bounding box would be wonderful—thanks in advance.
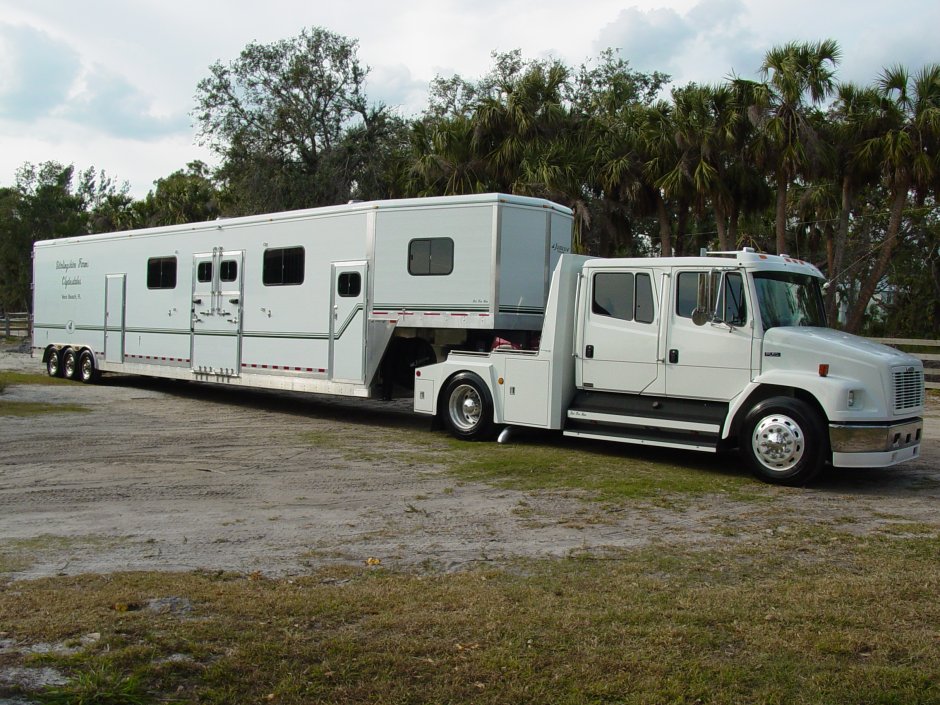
[846,64,940,333]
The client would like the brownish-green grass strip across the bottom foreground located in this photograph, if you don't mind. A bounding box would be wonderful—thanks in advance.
[0,524,940,705]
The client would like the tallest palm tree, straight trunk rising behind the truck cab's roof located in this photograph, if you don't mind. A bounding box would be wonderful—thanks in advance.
[753,39,841,254]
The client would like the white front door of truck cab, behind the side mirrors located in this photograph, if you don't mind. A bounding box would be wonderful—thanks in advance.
[666,269,753,401]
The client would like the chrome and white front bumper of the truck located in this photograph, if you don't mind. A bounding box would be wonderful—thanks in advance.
[829,418,924,467]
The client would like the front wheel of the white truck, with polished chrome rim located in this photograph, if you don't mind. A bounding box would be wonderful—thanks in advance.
[740,397,828,485]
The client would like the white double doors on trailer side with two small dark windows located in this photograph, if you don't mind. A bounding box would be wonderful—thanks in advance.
[191,248,244,377]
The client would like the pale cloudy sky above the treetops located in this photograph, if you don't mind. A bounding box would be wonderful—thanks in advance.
[0,0,940,198]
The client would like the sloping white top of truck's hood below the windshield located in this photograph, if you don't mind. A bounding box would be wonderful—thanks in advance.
[763,326,921,368]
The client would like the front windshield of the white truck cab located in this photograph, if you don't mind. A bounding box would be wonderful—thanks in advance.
[754,272,826,330]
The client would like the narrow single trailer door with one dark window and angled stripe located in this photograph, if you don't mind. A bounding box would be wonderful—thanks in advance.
[330,262,368,384]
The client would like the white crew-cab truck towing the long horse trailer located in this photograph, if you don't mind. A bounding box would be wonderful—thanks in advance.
[414,249,924,484]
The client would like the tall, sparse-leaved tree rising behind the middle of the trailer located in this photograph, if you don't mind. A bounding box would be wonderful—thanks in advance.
[194,28,388,213]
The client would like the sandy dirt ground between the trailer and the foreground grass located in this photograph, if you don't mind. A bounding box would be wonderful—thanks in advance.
[0,352,940,578]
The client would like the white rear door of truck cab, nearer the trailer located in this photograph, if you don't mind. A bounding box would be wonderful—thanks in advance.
[576,268,664,394]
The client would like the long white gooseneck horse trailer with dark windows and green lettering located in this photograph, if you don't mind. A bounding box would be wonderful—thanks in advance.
[33,194,572,397]
